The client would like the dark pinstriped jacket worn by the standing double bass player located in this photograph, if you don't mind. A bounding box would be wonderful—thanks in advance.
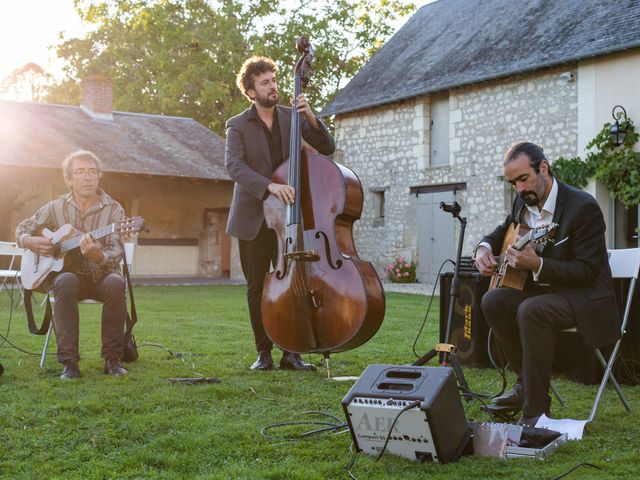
[225,105,335,240]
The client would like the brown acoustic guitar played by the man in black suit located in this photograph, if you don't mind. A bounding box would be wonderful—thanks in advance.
[489,222,558,290]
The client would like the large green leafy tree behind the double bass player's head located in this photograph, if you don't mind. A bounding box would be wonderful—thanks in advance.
[48,0,415,134]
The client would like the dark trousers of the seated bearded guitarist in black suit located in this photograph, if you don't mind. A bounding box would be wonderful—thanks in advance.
[482,286,576,417]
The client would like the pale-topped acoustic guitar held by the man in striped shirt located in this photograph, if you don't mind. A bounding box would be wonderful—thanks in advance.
[20,217,144,290]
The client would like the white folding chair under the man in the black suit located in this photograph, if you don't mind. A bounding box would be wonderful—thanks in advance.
[587,248,640,422]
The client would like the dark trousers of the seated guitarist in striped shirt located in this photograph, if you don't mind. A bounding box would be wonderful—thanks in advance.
[53,272,127,363]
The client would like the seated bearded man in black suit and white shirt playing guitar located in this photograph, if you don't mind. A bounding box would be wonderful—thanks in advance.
[475,142,620,426]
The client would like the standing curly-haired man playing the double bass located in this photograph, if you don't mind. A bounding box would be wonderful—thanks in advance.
[225,57,335,370]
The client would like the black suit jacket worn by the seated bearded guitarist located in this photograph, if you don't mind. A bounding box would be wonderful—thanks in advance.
[482,180,620,347]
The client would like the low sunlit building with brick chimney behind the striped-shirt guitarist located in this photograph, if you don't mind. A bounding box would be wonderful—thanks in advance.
[0,76,242,278]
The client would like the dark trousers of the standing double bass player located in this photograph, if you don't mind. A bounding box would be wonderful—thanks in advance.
[238,223,278,352]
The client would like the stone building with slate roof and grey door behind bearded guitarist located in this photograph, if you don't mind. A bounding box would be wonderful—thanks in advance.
[321,0,640,282]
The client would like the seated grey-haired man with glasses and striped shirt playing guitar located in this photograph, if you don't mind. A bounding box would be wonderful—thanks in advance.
[16,151,127,379]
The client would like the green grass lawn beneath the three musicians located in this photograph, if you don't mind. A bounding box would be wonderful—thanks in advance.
[0,286,640,480]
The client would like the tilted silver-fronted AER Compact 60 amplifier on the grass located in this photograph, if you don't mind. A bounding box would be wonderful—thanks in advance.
[342,365,469,463]
